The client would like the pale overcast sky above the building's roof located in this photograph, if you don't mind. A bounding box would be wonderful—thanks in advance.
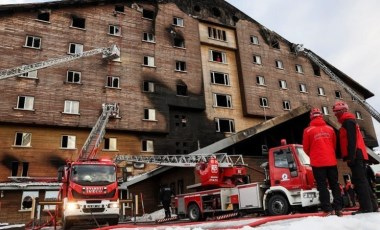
[0,0,380,149]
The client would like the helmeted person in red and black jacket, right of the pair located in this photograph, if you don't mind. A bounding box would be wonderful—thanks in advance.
[333,101,377,215]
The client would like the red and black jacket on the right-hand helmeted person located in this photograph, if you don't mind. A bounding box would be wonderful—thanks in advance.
[338,112,368,161]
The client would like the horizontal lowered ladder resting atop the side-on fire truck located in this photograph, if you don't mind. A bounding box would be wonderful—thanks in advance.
[114,153,246,168]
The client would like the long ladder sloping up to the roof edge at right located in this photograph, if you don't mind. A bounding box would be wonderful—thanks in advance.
[295,44,380,122]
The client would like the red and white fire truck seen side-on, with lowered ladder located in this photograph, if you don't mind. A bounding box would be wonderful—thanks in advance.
[116,141,320,221]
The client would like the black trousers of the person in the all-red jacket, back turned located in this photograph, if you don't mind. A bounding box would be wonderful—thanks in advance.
[313,166,343,212]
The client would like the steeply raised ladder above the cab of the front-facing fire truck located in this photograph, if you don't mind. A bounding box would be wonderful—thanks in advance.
[78,104,119,160]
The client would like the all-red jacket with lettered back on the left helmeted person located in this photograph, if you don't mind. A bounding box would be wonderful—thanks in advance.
[302,117,337,167]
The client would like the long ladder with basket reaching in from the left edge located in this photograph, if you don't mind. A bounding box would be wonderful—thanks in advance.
[0,45,120,80]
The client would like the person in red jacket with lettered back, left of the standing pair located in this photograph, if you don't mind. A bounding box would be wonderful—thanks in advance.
[302,108,343,216]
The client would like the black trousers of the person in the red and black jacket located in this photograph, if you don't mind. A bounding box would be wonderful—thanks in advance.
[349,157,377,212]
